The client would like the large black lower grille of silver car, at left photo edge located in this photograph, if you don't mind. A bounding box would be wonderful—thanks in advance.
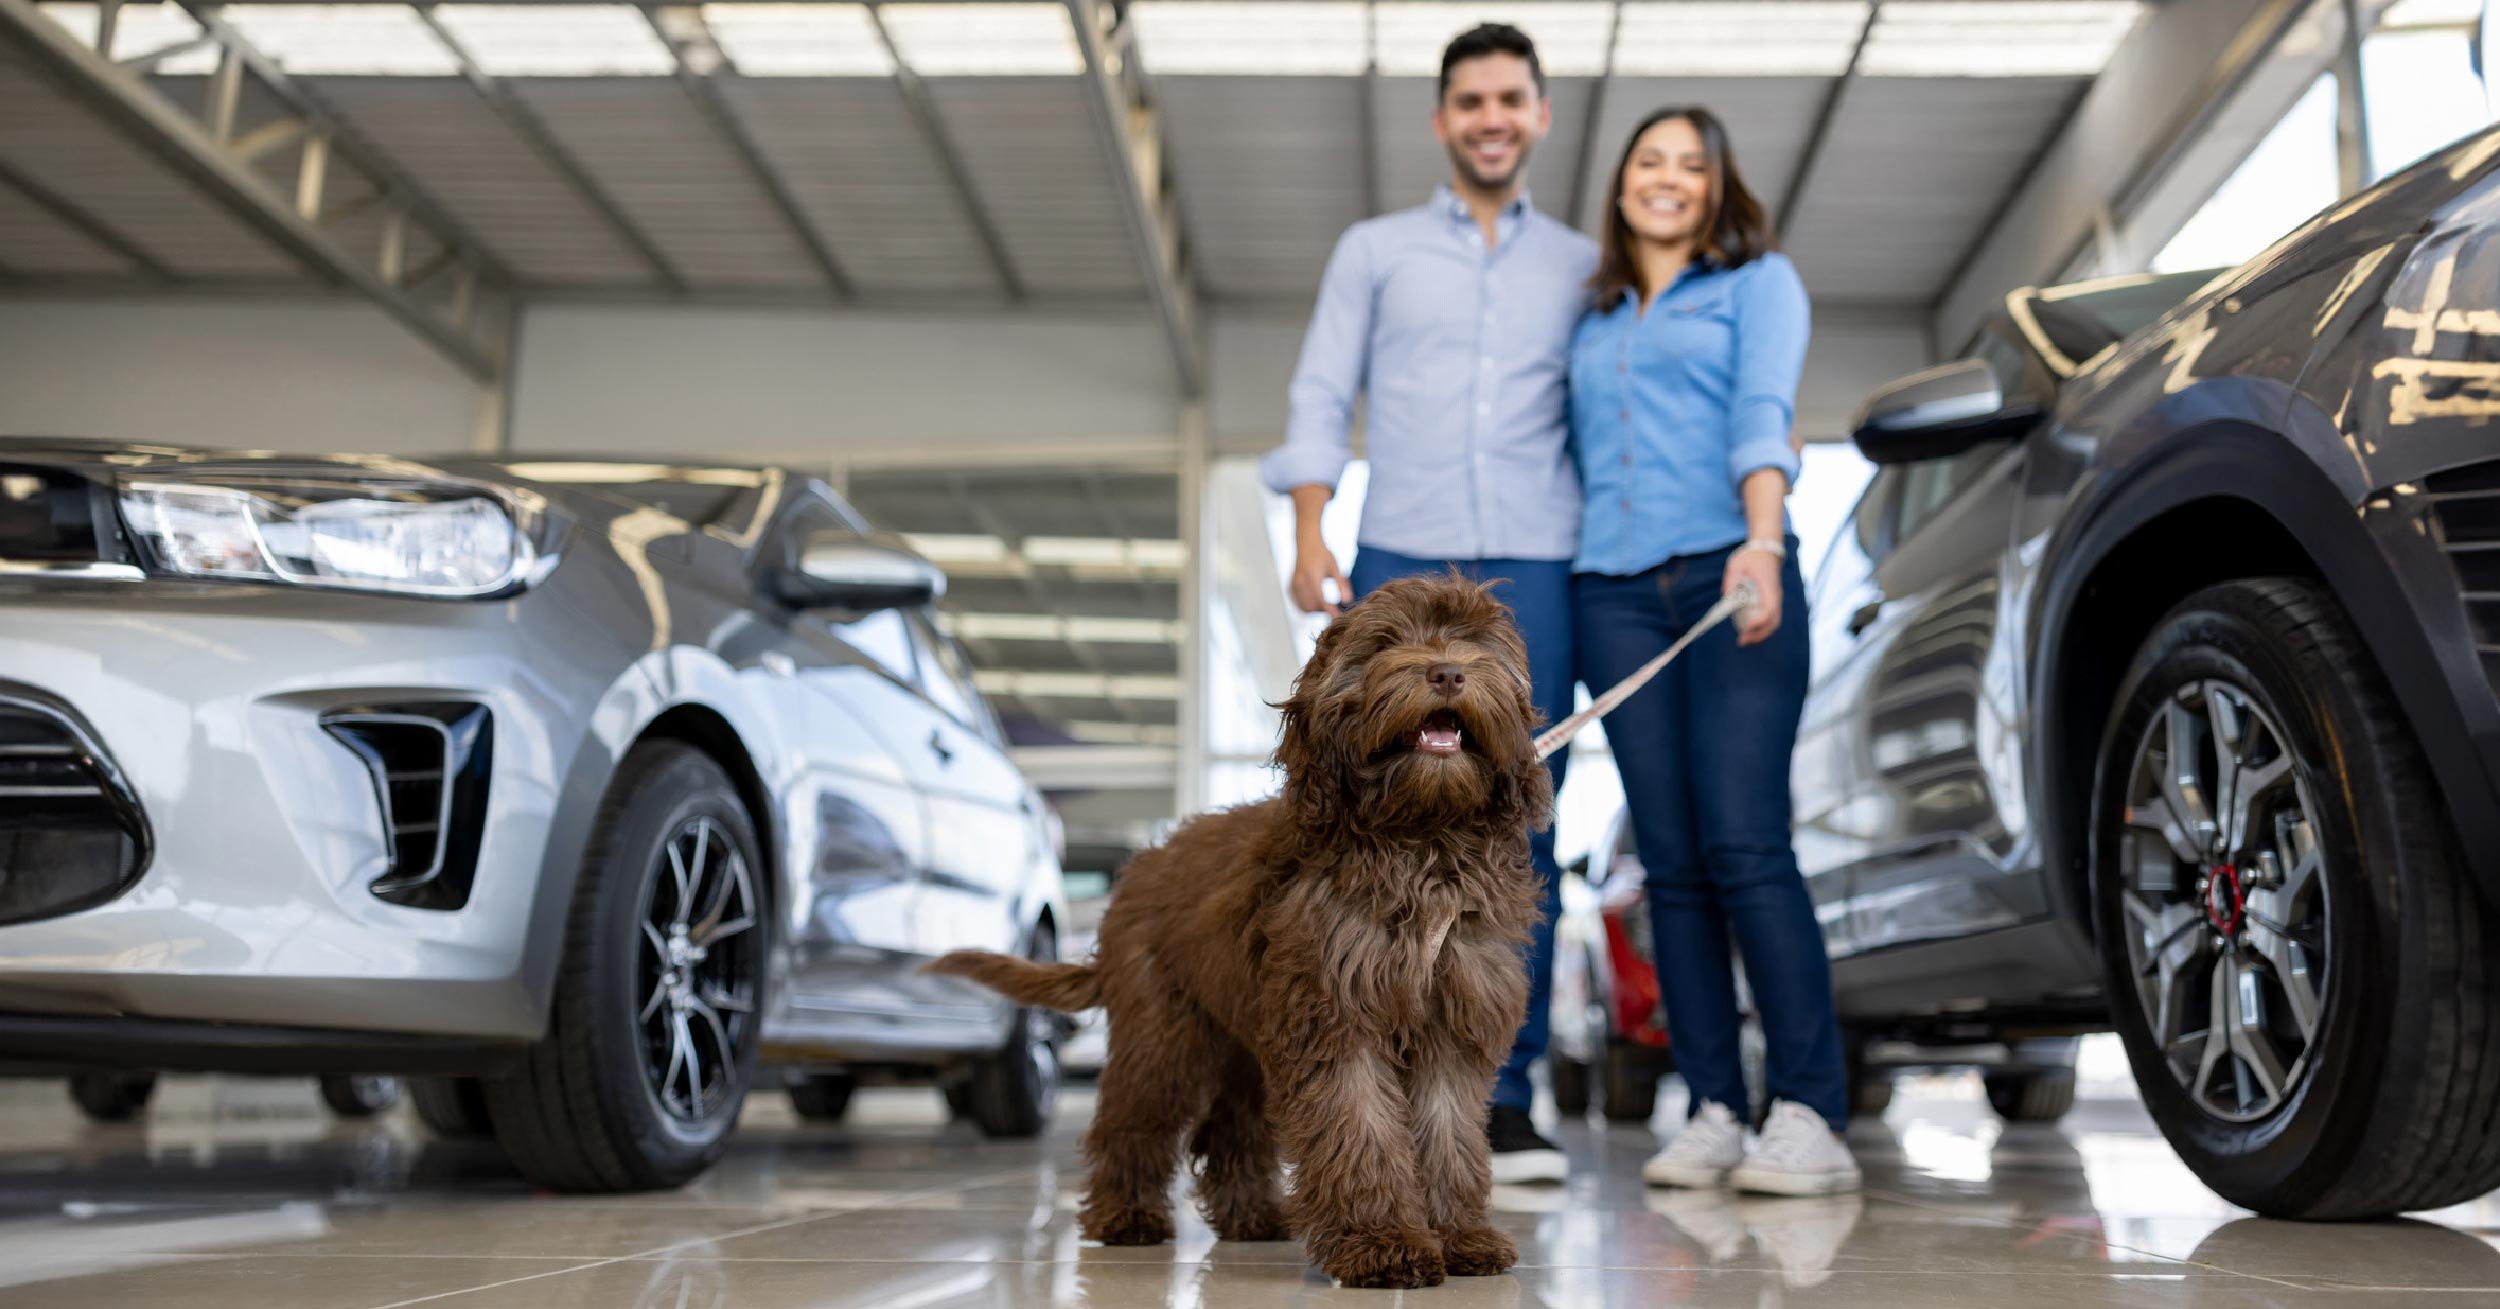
[0,684,150,922]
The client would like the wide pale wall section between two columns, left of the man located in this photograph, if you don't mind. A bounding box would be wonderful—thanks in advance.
[513,305,1178,467]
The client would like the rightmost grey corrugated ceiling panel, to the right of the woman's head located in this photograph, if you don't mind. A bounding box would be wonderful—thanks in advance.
[1788,77,2085,302]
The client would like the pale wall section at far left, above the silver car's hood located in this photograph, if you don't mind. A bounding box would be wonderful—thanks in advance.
[0,300,480,455]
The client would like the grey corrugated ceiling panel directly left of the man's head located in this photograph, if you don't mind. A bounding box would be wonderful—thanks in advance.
[1155,77,1370,300]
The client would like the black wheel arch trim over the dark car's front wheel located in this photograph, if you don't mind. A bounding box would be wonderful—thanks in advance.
[2033,420,2500,932]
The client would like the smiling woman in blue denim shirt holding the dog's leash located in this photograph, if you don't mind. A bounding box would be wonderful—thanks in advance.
[1570,107,1858,1194]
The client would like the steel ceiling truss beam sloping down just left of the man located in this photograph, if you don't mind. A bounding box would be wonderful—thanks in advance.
[1065,0,1205,400]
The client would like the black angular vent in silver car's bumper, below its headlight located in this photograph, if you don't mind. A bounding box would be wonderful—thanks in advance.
[320,704,495,909]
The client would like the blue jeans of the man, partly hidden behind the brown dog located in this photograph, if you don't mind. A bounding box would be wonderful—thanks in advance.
[1348,547,1570,1109]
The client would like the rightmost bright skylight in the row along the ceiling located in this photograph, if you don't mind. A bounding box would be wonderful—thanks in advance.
[1858,0,2143,77]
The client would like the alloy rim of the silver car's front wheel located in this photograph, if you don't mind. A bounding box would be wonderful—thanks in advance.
[635,817,763,1124]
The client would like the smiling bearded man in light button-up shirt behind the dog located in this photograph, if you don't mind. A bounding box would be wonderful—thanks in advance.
[1260,22,1598,1182]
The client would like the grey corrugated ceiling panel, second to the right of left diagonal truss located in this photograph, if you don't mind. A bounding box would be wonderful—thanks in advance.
[515,77,820,287]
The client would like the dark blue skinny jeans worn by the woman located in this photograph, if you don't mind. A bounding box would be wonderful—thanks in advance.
[1573,542,1850,1129]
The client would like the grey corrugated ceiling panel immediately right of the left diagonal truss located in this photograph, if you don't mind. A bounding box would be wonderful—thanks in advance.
[318,77,653,285]
